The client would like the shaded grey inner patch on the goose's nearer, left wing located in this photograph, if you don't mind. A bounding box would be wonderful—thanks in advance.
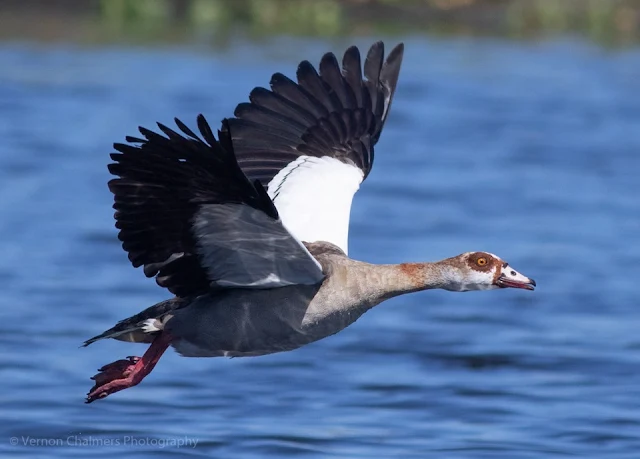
[193,204,324,288]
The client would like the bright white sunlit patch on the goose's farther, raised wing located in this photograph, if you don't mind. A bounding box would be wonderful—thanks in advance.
[267,156,364,253]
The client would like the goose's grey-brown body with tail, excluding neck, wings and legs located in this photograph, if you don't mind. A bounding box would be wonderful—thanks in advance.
[87,242,417,357]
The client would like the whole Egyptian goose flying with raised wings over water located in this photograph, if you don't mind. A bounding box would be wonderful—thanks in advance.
[84,42,536,403]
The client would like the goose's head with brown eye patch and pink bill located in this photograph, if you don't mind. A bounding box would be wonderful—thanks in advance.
[437,252,536,292]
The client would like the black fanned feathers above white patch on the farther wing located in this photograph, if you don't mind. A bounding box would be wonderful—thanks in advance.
[229,42,404,187]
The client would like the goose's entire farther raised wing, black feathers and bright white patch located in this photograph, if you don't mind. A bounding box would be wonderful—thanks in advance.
[229,42,404,253]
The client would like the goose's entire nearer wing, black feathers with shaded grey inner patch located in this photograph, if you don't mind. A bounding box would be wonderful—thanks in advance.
[109,115,324,296]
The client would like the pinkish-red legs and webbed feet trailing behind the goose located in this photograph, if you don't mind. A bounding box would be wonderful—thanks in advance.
[86,331,172,403]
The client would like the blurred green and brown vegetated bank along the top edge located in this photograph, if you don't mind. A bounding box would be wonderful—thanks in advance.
[0,0,640,45]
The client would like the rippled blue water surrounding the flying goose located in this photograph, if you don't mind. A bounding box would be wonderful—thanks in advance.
[0,37,640,459]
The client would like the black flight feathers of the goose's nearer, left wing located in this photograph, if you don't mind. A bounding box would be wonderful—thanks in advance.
[109,115,278,296]
